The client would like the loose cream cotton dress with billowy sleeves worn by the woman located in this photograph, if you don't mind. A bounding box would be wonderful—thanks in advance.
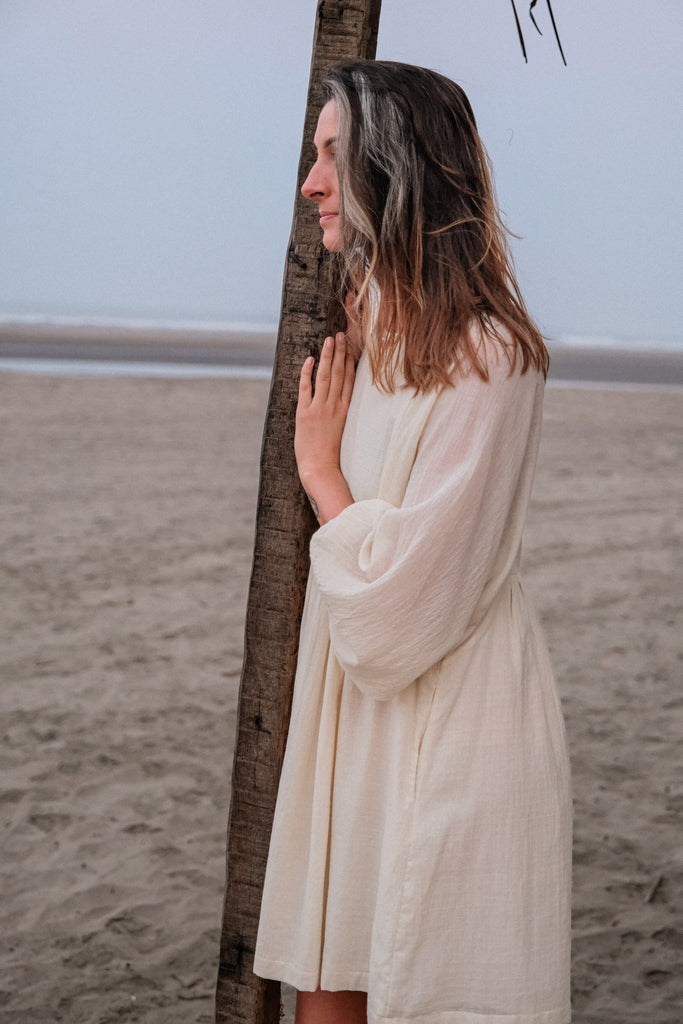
[255,340,571,1024]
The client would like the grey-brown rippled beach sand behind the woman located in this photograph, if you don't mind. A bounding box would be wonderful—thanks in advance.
[0,374,683,1024]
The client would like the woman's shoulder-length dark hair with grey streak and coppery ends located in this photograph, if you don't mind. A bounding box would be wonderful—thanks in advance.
[324,60,549,391]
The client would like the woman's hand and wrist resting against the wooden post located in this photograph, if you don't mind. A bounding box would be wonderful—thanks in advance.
[294,334,355,524]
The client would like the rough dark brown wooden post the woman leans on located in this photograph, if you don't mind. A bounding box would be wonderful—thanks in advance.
[215,0,381,1024]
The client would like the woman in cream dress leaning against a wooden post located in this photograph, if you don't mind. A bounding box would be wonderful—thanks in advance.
[255,61,570,1024]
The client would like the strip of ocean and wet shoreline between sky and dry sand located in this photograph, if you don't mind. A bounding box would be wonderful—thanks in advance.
[0,313,683,390]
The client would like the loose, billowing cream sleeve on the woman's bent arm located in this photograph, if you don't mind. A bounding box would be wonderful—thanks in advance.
[310,355,543,699]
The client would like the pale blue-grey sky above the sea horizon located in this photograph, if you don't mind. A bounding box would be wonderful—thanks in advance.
[0,0,683,344]
